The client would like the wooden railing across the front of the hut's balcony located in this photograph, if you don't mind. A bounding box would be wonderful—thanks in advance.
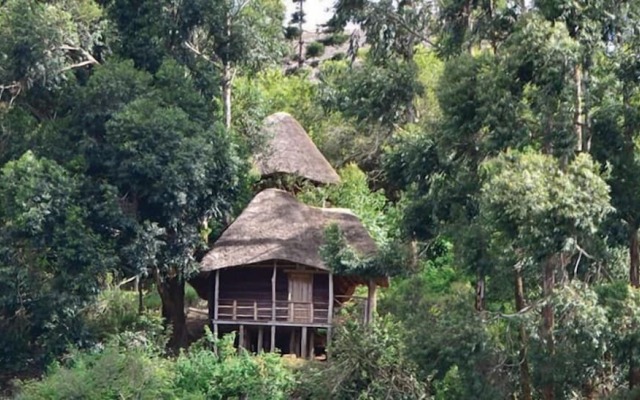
[218,299,329,324]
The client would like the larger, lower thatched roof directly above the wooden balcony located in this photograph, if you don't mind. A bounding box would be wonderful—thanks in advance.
[201,189,376,280]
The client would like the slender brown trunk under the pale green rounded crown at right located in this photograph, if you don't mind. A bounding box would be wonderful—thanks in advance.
[542,256,556,400]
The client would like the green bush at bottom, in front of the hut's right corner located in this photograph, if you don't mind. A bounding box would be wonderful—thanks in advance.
[296,318,427,400]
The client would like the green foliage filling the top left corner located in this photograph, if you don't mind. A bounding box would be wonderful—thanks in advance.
[0,0,104,96]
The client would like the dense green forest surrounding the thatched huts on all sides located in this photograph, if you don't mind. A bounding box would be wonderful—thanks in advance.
[0,0,640,400]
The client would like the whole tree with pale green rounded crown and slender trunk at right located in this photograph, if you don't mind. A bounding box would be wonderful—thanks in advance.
[481,152,612,399]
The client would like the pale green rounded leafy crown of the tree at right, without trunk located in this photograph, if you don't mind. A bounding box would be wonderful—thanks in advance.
[482,152,612,259]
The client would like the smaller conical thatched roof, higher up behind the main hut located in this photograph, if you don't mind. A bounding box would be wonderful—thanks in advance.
[254,112,340,183]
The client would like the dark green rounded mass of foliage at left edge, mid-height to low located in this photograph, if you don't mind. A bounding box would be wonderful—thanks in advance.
[0,152,115,368]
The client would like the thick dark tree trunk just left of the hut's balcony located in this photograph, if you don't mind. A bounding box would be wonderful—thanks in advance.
[158,276,187,351]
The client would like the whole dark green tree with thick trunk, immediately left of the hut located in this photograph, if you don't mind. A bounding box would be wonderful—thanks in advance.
[90,61,243,347]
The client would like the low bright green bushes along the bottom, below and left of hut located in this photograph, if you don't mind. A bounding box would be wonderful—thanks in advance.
[17,330,295,400]
